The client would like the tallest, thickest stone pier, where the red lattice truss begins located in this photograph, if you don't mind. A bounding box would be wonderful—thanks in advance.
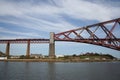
[49,32,55,58]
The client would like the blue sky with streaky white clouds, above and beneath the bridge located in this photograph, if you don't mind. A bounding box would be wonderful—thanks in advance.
[0,0,120,58]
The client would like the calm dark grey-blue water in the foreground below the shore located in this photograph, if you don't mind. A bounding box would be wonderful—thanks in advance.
[0,62,120,80]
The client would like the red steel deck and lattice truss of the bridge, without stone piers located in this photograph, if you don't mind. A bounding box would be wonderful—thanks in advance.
[0,18,120,51]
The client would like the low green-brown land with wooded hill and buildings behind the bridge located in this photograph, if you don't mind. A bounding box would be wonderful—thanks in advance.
[0,51,117,62]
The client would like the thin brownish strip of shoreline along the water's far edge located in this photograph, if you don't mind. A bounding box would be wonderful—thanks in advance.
[0,59,120,62]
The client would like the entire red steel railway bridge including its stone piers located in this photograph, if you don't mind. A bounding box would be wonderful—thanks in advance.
[0,18,120,58]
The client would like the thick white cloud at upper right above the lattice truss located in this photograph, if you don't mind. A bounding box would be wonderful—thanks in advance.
[60,0,120,21]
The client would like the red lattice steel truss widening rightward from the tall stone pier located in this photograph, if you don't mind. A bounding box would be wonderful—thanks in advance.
[54,18,120,51]
